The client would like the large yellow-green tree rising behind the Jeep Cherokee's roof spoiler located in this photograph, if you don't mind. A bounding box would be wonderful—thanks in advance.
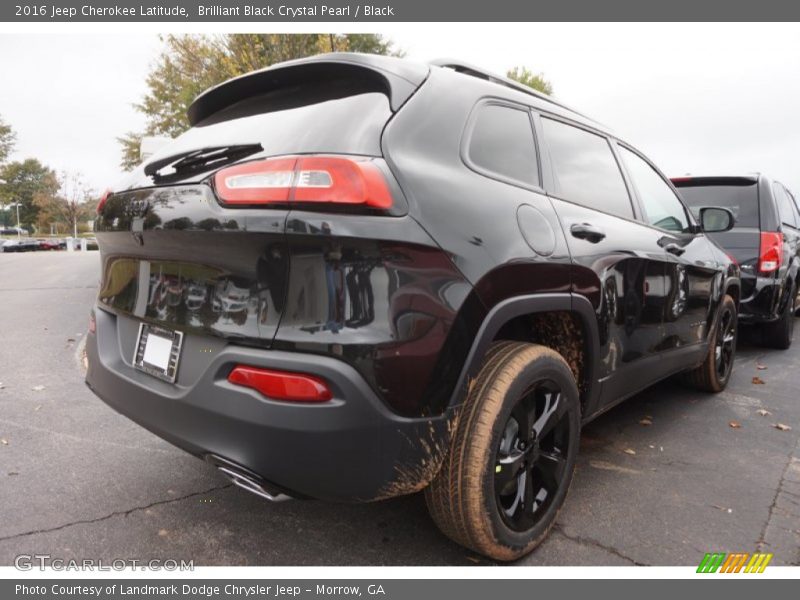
[117,33,399,170]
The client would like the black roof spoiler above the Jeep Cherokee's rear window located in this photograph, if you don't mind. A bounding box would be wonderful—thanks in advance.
[187,52,429,126]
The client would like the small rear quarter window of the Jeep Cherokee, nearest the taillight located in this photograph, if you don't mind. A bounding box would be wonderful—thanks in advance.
[467,104,539,186]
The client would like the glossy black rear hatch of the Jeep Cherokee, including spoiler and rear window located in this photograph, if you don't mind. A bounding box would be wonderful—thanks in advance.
[96,55,427,346]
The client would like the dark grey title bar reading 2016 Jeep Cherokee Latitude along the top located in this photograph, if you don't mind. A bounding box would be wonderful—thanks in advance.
[0,0,800,23]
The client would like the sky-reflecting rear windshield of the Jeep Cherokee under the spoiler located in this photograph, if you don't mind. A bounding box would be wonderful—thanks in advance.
[159,85,392,162]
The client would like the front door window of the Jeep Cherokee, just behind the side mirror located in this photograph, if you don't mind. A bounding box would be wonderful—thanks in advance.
[619,146,689,232]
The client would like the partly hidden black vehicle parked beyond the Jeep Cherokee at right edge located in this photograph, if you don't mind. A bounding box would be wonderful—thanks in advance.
[672,174,800,350]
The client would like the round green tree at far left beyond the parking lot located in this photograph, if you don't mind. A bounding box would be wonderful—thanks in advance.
[0,158,59,229]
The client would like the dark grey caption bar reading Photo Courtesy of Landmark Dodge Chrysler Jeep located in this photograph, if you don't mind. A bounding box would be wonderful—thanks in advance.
[0,574,797,600]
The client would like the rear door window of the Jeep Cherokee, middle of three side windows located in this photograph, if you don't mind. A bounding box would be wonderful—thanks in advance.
[542,118,633,218]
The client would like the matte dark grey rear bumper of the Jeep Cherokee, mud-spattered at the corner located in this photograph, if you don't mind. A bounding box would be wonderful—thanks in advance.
[86,309,453,501]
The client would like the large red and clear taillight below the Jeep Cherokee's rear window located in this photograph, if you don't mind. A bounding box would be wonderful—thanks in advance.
[214,156,392,209]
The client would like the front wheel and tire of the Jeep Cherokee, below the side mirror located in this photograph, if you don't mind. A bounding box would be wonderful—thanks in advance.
[684,295,739,394]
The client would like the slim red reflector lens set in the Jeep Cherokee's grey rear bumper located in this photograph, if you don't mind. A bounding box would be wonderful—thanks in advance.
[228,365,333,402]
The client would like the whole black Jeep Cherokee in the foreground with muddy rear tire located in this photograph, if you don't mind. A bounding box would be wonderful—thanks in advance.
[86,54,740,560]
